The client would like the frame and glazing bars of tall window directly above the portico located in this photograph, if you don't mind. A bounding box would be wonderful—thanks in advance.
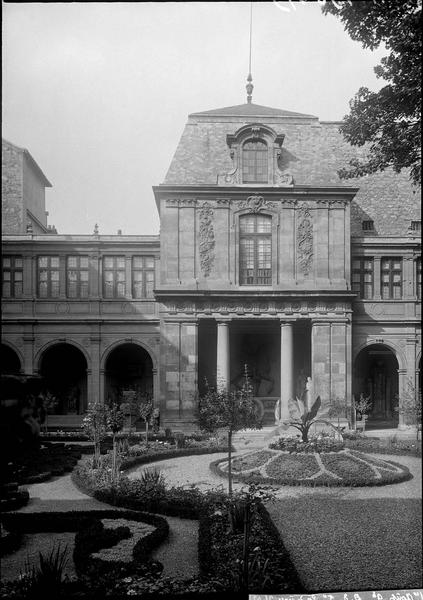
[238,213,273,287]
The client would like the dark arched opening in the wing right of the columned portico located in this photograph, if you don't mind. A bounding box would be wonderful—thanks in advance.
[353,344,399,427]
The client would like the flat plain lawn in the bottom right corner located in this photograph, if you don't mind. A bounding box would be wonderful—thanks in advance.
[267,494,422,592]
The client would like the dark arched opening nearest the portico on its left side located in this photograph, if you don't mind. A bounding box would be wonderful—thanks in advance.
[105,343,153,429]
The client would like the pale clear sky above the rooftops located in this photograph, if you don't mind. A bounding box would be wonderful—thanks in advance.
[2,2,386,235]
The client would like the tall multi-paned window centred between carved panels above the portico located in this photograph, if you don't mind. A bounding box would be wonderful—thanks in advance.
[239,215,272,285]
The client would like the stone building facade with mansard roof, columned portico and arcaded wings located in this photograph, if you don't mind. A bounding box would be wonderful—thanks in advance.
[2,102,421,430]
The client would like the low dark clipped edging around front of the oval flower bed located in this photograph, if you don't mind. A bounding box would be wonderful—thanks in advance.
[209,453,413,487]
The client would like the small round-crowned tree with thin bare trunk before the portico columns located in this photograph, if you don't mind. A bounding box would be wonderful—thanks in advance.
[198,367,262,496]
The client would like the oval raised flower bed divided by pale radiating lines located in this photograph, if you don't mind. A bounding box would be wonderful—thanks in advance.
[210,436,412,486]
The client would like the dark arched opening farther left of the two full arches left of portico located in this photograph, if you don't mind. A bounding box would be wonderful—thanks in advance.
[40,343,87,415]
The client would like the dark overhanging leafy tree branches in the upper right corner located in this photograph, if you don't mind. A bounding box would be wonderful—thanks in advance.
[322,0,421,184]
